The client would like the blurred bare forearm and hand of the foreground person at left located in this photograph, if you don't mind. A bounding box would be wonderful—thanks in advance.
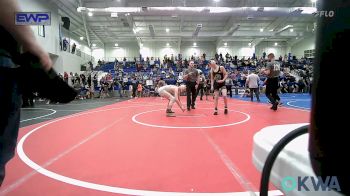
[0,0,52,70]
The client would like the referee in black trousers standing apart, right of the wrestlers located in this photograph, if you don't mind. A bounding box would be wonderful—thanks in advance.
[263,53,280,111]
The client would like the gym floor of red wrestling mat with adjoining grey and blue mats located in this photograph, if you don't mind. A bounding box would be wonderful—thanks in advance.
[0,94,310,196]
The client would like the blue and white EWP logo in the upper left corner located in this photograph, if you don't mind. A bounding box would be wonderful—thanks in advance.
[15,12,51,25]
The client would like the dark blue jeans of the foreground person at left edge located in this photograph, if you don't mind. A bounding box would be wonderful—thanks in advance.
[0,56,22,186]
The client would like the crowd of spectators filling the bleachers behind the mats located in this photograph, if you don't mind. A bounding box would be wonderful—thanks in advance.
[24,53,313,106]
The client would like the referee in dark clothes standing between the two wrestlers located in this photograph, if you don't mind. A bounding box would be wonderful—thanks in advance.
[183,61,199,111]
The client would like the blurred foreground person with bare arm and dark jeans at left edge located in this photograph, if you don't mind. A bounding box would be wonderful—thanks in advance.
[0,0,52,186]
